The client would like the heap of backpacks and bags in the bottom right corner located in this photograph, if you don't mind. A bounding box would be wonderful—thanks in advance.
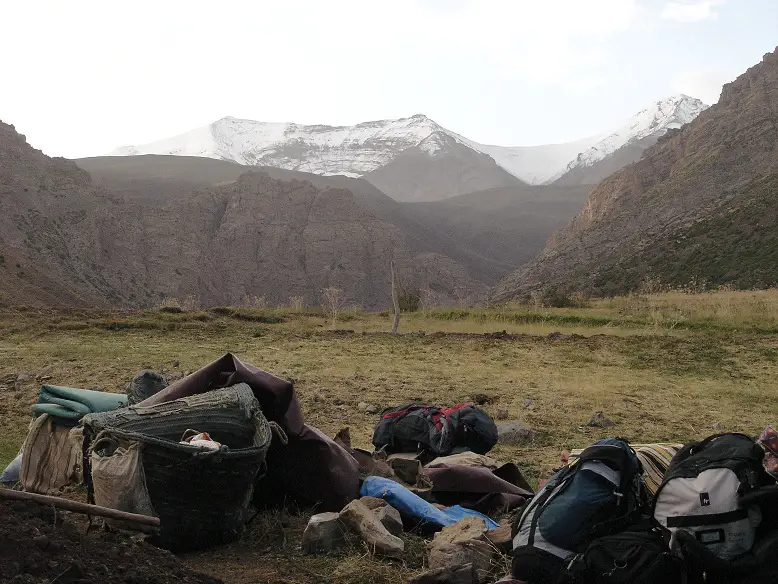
[513,427,778,584]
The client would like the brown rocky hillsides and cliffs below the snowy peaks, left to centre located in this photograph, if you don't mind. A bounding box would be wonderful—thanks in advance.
[0,124,504,308]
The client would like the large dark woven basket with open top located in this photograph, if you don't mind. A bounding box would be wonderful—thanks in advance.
[84,386,271,551]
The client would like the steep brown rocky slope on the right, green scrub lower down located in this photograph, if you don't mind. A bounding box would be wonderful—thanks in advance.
[496,49,778,299]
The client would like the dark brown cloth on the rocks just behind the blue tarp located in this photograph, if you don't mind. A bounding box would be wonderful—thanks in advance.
[424,464,533,515]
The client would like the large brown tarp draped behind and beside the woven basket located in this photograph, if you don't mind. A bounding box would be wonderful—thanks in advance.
[138,353,359,511]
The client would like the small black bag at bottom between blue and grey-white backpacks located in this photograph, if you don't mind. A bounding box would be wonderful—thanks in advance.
[568,518,683,584]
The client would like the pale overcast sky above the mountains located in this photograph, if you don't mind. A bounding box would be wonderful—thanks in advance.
[0,0,778,157]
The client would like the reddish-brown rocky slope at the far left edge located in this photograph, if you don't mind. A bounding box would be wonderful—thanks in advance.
[0,122,150,306]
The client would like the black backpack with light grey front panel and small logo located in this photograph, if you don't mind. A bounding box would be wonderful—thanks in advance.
[654,434,769,561]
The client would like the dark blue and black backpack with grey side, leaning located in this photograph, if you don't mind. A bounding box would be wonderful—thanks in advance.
[513,438,642,583]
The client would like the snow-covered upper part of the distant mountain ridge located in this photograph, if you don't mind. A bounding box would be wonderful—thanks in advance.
[111,95,707,184]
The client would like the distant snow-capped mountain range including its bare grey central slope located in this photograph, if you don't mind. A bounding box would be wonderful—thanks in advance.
[112,96,705,201]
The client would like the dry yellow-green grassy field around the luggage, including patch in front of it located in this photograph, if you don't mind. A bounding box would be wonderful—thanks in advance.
[0,291,778,584]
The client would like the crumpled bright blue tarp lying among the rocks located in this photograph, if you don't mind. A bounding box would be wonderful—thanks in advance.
[359,477,499,529]
